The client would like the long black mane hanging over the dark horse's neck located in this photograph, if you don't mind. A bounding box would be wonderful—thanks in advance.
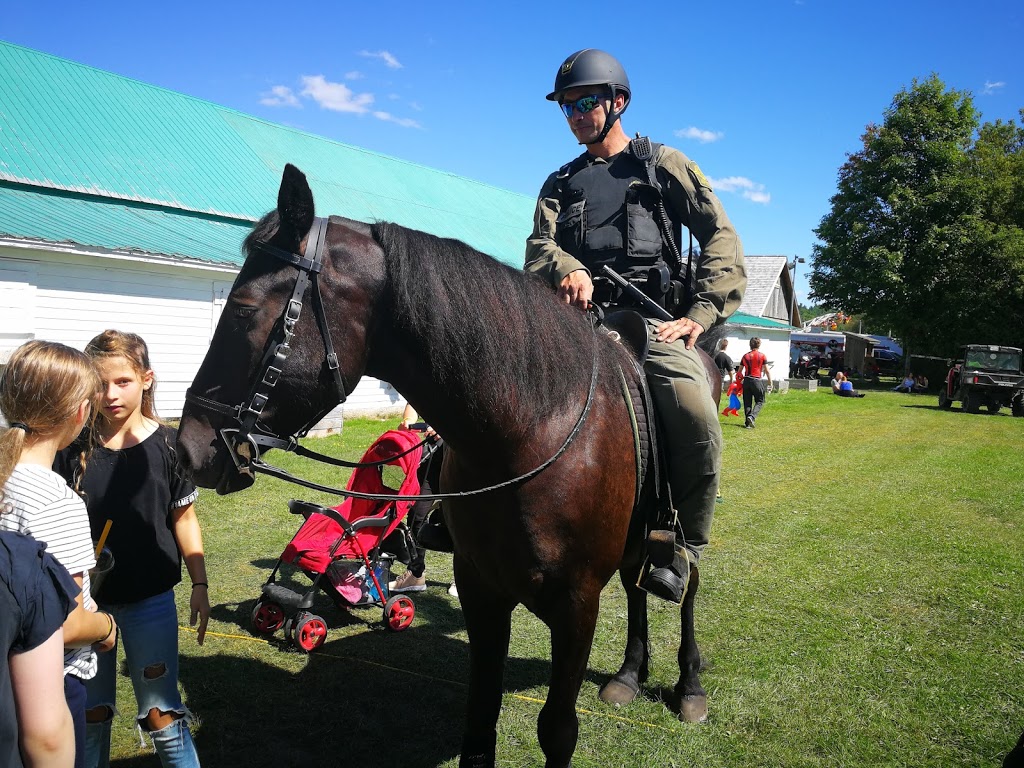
[372,222,603,428]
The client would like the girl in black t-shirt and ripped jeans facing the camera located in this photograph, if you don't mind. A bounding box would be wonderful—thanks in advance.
[57,331,210,768]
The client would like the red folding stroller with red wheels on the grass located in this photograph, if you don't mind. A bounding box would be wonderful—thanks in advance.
[252,430,423,653]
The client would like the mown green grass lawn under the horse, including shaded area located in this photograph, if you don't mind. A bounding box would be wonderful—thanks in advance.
[101,390,1024,768]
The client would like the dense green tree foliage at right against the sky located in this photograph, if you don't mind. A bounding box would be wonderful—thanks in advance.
[810,75,1024,354]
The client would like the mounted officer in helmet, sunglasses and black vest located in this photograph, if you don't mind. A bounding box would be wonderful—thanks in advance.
[525,48,746,603]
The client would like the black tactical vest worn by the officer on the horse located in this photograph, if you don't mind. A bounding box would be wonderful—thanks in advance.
[555,144,681,279]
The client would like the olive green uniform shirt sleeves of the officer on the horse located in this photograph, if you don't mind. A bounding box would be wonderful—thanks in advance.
[525,145,746,330]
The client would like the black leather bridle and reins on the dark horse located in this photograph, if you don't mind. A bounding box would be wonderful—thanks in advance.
[185,217,598,501]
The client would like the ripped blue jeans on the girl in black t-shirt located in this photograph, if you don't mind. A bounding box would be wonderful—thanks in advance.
[85,590,199,768]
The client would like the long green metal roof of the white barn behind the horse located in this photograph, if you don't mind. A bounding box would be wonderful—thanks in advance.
[0,42,535,266]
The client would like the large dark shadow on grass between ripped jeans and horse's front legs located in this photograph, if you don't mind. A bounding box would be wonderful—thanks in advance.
[182,630,465,768]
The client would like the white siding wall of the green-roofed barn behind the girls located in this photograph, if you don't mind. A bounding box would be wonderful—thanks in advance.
[0,248,404,423]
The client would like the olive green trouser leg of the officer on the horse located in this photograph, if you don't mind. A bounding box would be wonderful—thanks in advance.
[644,319,722,559]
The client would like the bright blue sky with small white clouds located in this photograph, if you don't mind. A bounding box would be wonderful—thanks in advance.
[0,0,1024,299]
